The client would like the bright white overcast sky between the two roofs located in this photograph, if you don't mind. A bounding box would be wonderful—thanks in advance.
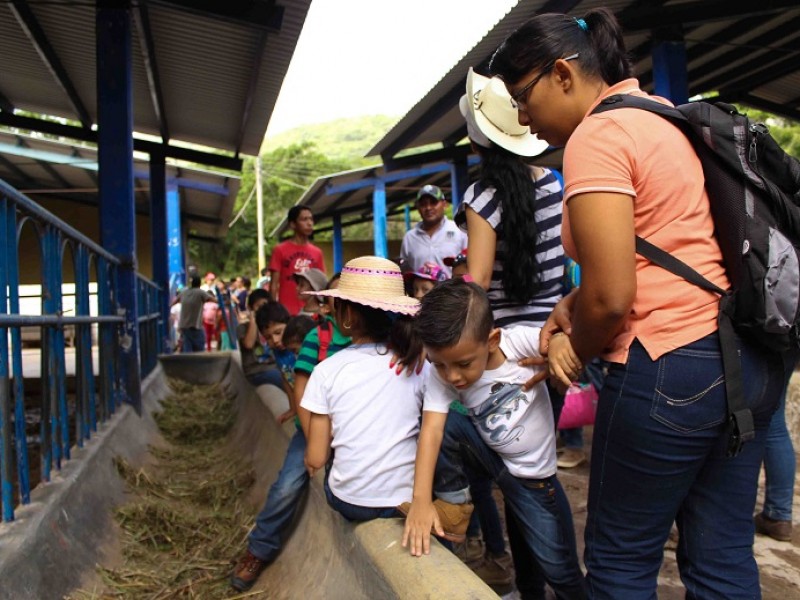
[267,0,517,137]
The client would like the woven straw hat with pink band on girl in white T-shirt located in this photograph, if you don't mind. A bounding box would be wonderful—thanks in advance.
[304,256,419,315]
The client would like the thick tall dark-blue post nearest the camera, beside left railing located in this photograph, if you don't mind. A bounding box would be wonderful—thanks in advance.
[96,2,142,413]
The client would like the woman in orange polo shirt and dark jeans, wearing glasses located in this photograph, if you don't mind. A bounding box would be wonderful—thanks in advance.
[490,9,785,600]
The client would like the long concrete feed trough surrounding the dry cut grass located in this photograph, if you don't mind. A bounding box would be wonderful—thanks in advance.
[0,353,497,600]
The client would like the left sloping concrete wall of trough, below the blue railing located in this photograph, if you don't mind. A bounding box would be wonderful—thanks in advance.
[0,367,169,600]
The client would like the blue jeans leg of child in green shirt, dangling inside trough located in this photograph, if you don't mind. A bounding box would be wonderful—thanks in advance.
[248,429,309,562]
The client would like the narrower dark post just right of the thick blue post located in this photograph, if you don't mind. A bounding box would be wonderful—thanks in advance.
[150,152,170,352]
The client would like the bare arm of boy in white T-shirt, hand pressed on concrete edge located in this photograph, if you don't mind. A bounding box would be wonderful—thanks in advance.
[403,410,447,556]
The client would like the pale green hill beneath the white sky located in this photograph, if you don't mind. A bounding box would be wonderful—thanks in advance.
[261,115,397,167]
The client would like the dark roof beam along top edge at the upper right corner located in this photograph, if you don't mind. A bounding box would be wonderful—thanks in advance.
[619,0,797,32]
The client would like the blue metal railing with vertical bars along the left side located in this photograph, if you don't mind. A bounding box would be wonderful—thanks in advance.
[0,181,164,521]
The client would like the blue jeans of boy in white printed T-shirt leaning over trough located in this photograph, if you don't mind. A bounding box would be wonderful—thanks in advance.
[433,411,586,599]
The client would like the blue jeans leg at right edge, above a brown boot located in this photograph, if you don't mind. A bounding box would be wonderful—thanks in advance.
[764,358,797,521]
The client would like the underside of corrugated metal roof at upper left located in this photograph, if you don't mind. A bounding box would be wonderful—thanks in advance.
[0,0,311,155]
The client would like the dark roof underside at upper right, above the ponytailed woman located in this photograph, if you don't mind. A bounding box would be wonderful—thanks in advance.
[367,0,800,160]
